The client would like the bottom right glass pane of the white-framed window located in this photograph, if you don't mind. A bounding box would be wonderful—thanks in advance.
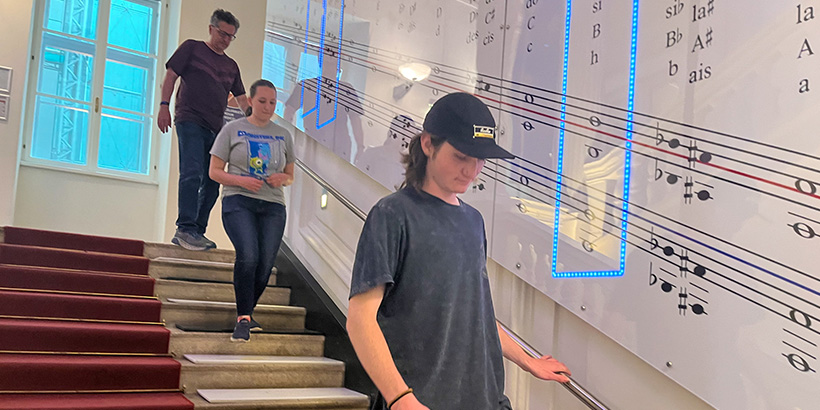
[97,110,151,175]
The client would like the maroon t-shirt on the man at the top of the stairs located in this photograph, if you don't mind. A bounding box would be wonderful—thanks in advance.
[165,40,245,132]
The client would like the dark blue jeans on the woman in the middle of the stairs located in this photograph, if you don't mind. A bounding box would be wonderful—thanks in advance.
[222,195,287,316]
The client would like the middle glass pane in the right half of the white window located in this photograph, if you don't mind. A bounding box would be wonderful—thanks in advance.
[103,56,149,113]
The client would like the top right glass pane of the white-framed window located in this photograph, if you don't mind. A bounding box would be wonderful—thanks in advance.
[108,0,154,54]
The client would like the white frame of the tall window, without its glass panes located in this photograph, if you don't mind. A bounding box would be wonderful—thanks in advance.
[20,0,169,185]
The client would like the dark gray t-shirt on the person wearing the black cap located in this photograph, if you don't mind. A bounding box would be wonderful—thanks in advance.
[350,188,510,410]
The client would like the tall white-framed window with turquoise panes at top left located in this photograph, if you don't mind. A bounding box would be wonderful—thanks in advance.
[27,0,161,178]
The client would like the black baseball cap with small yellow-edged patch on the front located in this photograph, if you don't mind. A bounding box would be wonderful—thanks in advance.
[424,93,515,159]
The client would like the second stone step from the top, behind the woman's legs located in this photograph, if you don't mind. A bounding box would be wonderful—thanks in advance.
[148,258,276,286]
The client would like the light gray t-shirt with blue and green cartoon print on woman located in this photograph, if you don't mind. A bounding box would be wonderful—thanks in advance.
[211,118,296,205]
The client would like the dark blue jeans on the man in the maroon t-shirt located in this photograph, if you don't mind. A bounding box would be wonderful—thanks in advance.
[175,121,219,234]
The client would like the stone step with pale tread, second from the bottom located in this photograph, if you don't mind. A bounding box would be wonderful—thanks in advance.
[180,355,344,393]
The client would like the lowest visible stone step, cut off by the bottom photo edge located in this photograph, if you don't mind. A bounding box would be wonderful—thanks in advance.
[188,387,370,410]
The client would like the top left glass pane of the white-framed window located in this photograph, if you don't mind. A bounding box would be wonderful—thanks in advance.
[43,0,99,40]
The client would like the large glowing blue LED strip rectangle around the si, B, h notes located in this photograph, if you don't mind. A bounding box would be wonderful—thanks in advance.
[552,0,639,278]
